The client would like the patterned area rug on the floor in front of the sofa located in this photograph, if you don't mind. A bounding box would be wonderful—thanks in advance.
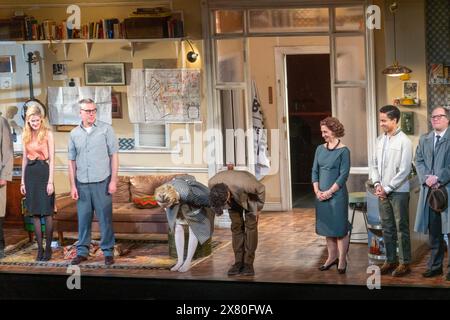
[0,239,226,270]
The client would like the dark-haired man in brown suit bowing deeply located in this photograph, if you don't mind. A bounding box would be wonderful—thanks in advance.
[209,170,266,276]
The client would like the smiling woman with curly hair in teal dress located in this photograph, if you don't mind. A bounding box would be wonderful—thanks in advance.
[312,117,350,274]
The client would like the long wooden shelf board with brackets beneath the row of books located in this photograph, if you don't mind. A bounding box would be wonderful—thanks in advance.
[0,38,187,60]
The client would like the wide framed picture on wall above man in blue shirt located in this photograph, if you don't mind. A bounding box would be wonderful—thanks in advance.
[84,63,126,86]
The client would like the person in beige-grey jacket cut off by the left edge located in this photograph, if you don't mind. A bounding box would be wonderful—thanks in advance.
[0,116,14,258]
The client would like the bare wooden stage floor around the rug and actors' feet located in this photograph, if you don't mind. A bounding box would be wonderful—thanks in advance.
[0,209,450,288]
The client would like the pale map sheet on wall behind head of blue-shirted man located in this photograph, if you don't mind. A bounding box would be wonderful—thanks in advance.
[48,86,112,125]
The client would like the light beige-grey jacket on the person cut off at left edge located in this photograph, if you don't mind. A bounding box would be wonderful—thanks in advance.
[0,116,14,181]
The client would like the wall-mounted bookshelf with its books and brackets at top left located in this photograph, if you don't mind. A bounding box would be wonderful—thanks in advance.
[0,0,185,59]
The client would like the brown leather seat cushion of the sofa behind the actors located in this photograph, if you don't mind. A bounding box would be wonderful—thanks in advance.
[55,202,167,223]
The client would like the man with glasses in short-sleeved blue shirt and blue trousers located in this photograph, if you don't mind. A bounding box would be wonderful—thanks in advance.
[69,99,119,265]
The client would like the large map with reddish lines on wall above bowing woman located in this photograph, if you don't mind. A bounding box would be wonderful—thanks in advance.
[128,69,200,123]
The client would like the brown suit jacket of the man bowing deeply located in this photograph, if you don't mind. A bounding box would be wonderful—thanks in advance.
[209,170,266,214]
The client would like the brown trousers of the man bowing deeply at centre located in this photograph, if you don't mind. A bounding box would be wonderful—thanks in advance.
[229,210,258,265]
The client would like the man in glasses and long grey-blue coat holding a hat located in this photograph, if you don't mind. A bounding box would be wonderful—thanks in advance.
[414,107,450,281]
